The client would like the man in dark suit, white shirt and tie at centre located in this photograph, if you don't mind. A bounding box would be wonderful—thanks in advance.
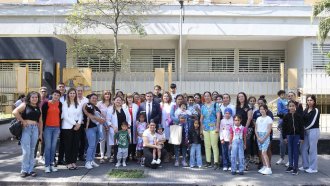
[137,92,162,124]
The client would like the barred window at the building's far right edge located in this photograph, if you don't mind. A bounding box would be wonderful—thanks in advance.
[312,44,330,69]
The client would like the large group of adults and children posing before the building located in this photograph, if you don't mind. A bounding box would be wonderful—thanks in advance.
[13,83,320,177]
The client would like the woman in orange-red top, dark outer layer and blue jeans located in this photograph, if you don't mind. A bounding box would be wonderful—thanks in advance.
[42,90,62,173]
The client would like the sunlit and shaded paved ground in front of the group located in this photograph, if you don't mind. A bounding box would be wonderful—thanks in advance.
[0,141,330,186]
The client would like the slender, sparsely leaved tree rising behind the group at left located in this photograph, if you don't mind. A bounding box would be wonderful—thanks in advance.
[67,0,152,95]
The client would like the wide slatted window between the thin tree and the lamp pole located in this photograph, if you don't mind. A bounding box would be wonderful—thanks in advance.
[130,49,175,72]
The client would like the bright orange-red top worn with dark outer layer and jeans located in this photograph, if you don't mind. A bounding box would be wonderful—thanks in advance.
[46,101,61,127]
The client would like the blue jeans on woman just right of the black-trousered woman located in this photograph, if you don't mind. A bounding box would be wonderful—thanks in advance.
[86,127,99,162]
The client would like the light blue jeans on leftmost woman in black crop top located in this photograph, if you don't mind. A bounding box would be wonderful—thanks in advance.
[21,125,39,173]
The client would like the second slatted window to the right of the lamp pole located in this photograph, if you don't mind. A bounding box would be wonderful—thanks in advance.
[239,50,285,73]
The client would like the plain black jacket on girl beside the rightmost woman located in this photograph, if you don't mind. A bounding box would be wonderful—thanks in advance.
[282,113,305,140]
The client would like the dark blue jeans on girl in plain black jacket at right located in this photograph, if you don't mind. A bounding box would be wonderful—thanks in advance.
[287,135,300,169]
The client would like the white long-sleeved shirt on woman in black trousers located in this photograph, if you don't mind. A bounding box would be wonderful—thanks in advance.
[62,103,83,129]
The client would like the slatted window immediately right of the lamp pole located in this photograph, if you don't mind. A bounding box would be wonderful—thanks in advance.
[188,49,234,72]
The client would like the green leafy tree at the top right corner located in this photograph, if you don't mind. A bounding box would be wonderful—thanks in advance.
[312,0,330,76]
